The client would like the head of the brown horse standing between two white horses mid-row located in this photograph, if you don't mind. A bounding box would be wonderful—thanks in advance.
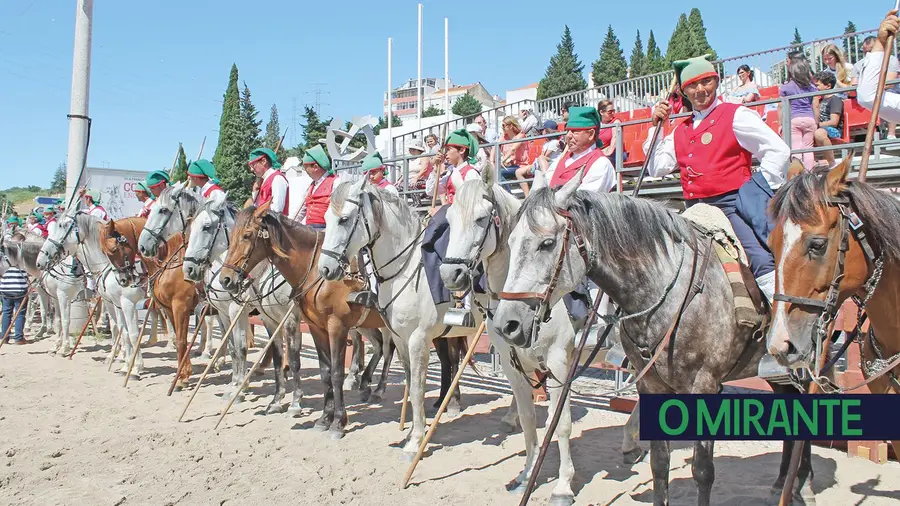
[219,201,277,293]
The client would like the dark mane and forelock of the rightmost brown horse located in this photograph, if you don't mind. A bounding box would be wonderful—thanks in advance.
[769,167,900,265]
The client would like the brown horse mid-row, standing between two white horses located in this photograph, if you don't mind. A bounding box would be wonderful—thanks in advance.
[219,202,387,439]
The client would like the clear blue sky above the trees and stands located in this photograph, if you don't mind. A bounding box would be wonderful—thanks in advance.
[0,0,893,188]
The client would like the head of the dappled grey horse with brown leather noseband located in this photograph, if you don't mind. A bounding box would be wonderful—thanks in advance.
[492,171,588,347]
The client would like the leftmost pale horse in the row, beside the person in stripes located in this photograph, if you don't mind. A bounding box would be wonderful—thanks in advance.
[3,236,77,344]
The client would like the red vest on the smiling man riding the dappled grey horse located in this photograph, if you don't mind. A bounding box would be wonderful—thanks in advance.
[674,103,751,200]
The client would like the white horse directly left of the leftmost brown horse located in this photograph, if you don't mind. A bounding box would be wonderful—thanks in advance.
[37,211,146,377]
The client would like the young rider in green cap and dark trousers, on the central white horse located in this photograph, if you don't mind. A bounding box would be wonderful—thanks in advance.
[422,128,483,327]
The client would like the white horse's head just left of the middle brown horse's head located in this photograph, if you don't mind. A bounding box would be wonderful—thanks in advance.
[182,192,228,282]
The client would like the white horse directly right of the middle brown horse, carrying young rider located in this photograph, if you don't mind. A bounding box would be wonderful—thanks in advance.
[318,178,515,459]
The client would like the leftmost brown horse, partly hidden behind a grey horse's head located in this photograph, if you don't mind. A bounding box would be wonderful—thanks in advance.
[99,217,200,390]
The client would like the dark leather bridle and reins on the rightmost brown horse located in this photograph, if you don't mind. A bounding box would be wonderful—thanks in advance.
[774,190,900,392]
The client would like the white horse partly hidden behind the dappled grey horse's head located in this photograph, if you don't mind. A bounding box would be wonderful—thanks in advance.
[441,170,644,505]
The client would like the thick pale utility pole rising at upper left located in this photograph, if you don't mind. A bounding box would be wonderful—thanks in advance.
[66,0,94,208]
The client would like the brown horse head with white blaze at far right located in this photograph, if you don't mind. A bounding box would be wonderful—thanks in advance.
[766,157,876,368]
